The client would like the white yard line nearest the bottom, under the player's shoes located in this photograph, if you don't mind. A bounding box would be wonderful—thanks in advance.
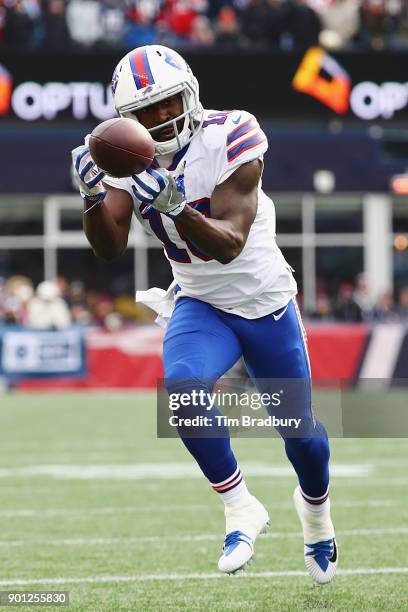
[0,567,408,587]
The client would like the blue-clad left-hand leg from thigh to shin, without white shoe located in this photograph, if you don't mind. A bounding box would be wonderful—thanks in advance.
[163,298,241,489]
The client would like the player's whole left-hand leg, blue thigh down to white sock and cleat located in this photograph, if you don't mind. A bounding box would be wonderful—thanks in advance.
[163,298,269,573]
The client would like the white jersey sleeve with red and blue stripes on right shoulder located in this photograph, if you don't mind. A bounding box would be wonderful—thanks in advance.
[217,111,268,185]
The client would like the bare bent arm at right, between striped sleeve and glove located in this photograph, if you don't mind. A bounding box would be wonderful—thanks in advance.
[174,159,262,264]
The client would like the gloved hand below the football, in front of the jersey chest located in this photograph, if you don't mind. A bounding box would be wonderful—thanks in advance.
[132,161,186,217]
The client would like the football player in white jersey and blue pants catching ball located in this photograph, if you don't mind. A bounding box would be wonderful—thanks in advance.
[73,45,337,583]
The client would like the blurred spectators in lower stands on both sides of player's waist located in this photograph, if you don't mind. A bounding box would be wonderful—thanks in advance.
[0,273,408,331]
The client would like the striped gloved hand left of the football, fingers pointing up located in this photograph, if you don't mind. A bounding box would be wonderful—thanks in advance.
[71,137,106,202]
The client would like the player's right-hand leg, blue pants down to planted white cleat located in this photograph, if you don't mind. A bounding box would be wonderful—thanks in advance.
[230,301,337,583]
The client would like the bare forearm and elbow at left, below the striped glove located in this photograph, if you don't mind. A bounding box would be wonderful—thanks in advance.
[83,184,133,261]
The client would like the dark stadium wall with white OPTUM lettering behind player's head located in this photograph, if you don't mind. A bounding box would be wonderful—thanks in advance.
[0,47,408,193]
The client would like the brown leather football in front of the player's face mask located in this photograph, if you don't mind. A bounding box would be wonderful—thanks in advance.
[89,117,155,178]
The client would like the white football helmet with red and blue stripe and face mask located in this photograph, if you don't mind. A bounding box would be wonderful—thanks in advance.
[112,45,203,155]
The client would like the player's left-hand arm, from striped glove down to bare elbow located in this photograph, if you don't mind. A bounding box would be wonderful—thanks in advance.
[72,145,133,260]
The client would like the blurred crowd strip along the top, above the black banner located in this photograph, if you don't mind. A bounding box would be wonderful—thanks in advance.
[0,0,408,51]
